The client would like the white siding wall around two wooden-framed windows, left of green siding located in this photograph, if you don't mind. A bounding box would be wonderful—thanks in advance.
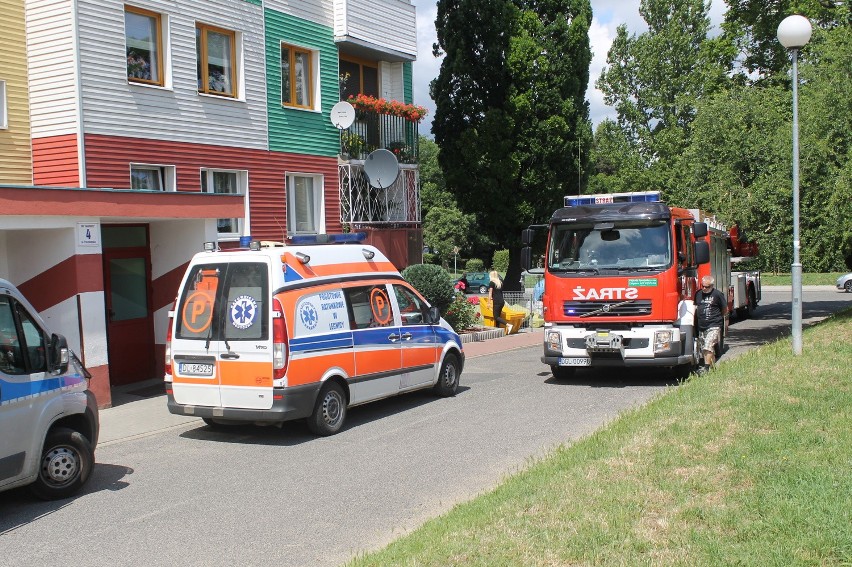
[77,0,267,149]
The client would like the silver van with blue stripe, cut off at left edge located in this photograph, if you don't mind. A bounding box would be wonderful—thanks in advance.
[0,279,99,500]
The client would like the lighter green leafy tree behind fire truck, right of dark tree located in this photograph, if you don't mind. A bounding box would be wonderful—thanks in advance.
[596,0,734,193]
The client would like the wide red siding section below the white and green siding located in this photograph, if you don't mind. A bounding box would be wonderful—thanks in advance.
[85,134,341,240]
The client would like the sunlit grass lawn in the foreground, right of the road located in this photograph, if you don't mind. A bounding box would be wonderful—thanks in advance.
[350,310,852,567]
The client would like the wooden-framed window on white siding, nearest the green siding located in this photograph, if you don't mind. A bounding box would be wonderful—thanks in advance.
[195,24,237,97]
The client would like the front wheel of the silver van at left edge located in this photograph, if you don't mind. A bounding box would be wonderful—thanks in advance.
[30,427,95,500]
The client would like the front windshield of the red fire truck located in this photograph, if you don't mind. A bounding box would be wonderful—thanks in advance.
[547,221,672,272]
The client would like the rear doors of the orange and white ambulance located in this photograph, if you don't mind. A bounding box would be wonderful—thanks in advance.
[172,260,273,409]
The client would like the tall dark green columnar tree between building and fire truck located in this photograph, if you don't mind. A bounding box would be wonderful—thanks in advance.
[431,0,592,285]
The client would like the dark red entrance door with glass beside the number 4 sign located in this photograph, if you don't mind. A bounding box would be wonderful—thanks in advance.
[101,226,155,386]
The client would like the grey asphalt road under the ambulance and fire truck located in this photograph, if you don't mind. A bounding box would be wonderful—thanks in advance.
[0,289,852,566]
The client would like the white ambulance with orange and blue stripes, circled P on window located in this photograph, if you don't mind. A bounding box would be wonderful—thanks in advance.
[165,233,464,436]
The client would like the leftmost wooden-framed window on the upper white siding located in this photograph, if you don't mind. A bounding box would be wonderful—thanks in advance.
[124,6,163,86]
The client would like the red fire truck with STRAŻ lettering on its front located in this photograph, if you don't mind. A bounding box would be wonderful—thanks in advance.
[521,191,760,378]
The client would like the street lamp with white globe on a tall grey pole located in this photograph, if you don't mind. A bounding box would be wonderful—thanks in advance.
[778,16,811,355]
